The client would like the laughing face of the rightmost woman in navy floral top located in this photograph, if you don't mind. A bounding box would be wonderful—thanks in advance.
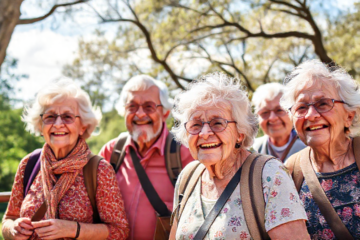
[293,81,355,148]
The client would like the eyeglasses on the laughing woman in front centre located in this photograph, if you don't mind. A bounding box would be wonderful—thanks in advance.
[184,118,236,135]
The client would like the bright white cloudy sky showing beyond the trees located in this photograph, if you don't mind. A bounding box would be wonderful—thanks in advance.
[7,0,356,110]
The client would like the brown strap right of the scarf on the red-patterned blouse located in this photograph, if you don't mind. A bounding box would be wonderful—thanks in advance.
[83,153,103,223]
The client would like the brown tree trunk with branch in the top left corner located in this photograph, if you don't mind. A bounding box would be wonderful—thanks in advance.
[0,0,88,66]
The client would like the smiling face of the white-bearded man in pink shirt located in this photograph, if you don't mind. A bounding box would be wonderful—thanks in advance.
[125,86,169,143]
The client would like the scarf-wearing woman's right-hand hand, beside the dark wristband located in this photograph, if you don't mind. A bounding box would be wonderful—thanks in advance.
[32,219,77,239]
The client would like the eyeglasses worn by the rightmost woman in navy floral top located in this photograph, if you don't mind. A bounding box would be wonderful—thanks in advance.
[289,98,347,118]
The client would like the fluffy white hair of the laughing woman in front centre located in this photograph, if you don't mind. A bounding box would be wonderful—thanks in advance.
[172,73,258,148]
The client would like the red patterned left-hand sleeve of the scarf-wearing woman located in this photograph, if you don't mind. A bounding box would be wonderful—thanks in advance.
[4,154,30,219]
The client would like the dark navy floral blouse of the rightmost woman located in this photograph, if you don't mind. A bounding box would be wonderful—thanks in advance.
[300,163,360,239]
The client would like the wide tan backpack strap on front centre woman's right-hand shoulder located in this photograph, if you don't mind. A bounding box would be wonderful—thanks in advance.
[240,153,275,239]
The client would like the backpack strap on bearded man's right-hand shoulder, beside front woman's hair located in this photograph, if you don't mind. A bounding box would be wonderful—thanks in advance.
[164,132,182,187]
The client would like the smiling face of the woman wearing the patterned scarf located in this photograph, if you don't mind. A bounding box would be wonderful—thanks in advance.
[41,98,86,155]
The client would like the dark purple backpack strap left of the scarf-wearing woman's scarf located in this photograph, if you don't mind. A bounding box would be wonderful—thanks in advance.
[23,148,42,198]
